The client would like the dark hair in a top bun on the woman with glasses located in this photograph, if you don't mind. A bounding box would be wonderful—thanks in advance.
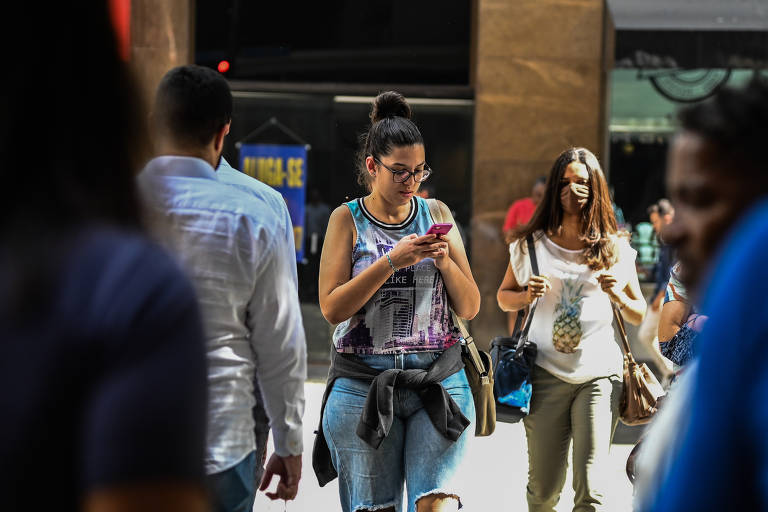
[357,91,424,190]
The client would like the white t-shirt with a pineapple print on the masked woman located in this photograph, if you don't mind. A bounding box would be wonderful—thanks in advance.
[509,232,637,384]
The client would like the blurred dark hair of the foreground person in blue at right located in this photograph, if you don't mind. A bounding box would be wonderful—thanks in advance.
[678,75,768,185]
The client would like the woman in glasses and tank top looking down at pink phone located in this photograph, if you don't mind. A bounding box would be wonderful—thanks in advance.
[314,92,480,511]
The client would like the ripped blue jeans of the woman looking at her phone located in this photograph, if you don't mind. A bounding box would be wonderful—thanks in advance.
[323,352,475,512]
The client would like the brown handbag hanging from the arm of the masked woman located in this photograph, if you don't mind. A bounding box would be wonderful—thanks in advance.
[611,303,665,426]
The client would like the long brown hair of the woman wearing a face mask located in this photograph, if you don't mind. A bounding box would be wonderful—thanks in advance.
[513,148,618,270]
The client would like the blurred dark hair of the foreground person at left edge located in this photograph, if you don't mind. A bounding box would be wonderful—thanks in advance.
[0,1,149,312]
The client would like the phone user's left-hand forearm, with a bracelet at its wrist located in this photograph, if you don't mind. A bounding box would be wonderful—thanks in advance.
[320,256,394,324]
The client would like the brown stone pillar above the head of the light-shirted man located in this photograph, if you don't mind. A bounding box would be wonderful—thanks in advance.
[130,0,195,104]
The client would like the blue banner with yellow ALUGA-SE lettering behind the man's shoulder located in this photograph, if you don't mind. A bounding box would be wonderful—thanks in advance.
[240,144,307,261]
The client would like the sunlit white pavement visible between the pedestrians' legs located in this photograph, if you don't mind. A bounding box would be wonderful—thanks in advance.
[254,382,632,512]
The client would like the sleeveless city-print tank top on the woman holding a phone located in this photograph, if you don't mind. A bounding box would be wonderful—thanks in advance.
[333,197,461,354]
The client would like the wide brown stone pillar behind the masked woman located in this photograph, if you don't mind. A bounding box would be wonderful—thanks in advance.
[471,0,613,345]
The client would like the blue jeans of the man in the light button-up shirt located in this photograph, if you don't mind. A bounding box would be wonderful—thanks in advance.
[208,451,261,512]
